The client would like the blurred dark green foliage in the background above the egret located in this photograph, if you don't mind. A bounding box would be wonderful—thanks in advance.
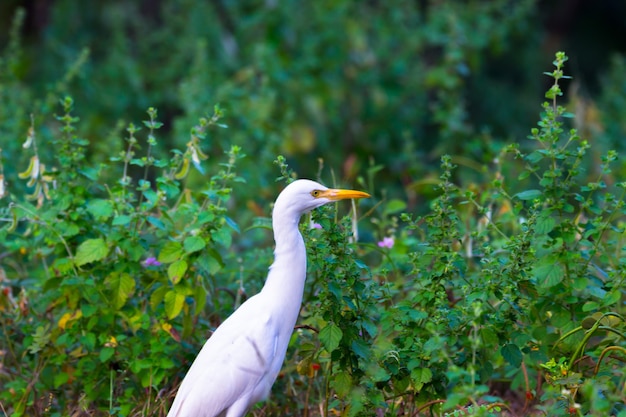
[3,0,541,195]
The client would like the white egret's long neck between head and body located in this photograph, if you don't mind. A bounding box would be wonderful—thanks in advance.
[263,211,306,320]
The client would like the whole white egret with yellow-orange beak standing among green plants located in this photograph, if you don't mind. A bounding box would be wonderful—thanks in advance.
[167,180,369,417]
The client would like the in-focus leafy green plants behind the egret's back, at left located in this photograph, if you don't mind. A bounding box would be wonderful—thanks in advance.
[0,97,243,416]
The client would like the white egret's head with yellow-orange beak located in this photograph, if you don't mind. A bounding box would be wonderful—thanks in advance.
[274,180,370,217]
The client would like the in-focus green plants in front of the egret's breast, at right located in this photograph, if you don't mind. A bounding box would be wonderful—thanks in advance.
[254,53,626,416]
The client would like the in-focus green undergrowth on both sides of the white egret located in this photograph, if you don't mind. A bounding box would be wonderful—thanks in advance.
[0,25,626,416]
